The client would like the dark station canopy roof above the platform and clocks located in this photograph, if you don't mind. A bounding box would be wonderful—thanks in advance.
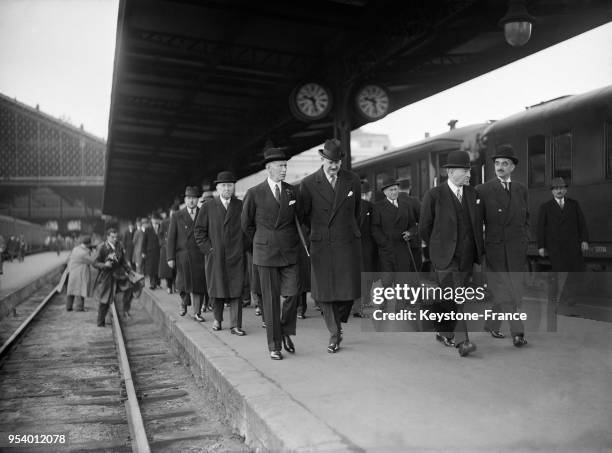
[103,0,612,217]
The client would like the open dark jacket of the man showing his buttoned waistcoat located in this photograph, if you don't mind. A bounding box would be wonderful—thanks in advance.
[419,183,483,269]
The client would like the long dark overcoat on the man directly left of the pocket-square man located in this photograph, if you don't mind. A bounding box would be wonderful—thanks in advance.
[194,197,245,299]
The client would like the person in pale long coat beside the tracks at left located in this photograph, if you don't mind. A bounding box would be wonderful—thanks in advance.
[66,236,95,311]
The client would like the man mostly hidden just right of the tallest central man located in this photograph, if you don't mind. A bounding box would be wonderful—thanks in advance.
[353,179,378,318]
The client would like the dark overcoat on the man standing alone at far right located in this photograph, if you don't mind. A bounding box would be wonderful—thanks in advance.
[538,197,589,272]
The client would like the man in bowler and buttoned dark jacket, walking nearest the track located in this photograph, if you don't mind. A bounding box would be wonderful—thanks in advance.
[242,148,300,360]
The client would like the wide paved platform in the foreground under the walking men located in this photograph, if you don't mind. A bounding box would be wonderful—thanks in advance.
[135,289,612,452]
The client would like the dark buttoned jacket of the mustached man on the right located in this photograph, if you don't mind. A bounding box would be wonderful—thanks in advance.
[476,178,529,272]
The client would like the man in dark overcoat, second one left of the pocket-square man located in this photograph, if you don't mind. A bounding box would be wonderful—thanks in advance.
[166,186,206,322]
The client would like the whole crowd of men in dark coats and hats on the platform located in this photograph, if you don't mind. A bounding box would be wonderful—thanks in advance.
[95,139,588,360]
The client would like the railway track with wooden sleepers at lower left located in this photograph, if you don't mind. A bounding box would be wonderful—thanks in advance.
[0,280,249,452]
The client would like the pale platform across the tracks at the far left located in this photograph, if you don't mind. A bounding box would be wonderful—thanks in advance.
[0,251,70,299]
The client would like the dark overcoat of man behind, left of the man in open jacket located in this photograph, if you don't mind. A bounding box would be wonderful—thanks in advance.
[370,198,417,272]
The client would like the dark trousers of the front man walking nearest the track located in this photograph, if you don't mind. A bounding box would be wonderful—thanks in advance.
[257,265,298,351]
